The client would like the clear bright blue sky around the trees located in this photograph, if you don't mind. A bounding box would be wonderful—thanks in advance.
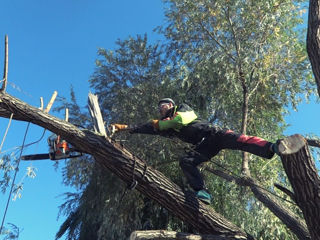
[0,0,320,240]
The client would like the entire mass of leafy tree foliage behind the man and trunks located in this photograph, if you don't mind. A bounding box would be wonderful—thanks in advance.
[4,0,316,239]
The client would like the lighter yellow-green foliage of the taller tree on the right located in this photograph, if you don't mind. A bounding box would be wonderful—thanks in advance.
[159,0,315,239]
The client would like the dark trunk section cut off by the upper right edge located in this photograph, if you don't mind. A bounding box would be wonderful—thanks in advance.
[307,0,320,96]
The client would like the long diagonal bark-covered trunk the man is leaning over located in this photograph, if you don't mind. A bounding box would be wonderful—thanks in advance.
[0,92,251,239]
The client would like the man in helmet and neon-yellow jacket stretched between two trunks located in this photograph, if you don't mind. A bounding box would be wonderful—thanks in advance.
[112,98,278,204]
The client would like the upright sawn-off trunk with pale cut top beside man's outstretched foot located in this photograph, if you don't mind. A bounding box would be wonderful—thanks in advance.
[279,134,320,240]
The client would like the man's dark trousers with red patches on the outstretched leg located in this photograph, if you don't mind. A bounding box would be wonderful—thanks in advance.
[180,129,274,191]
